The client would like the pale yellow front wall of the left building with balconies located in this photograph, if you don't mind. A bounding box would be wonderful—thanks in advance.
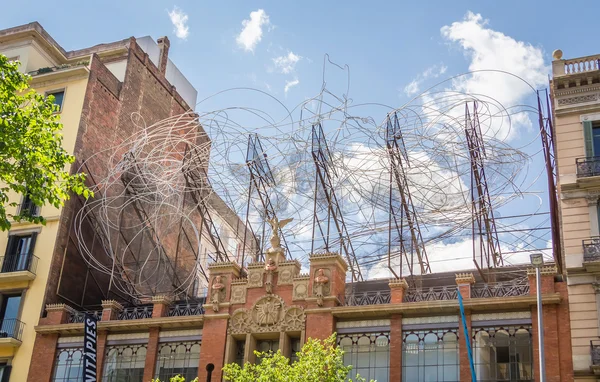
[0,44,89,381]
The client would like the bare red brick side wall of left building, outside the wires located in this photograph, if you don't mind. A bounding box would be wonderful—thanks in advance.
[45,38,193,307]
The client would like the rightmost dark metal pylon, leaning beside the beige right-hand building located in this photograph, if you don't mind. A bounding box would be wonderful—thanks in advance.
[537,90,563,274]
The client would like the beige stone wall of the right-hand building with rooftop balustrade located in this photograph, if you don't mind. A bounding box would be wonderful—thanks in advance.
[551,53,600,381]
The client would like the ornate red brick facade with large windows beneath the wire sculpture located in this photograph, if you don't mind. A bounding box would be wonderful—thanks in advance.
[29,253,573,382]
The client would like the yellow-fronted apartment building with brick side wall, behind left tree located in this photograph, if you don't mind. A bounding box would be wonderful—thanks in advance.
[0,22,248,382]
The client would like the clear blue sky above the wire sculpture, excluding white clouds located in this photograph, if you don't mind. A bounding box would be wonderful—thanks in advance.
[0,0,600,109]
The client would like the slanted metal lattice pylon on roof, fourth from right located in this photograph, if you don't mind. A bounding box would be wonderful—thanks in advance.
[311,123,363,281]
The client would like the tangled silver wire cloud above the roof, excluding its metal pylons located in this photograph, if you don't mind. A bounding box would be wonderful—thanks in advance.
[76,66,550,297]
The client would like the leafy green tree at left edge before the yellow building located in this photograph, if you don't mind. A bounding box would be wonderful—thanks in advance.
[0,54,93,231]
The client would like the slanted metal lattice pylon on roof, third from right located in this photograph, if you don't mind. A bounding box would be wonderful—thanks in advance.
[386,113,431,277]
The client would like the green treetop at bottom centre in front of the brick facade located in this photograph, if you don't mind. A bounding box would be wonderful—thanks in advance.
[223,334,372,382]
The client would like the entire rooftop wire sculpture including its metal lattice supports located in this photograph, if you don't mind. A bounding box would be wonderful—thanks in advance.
[75,56,556,299]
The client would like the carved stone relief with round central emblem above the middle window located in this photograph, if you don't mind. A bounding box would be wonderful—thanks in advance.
[227,295,306,334]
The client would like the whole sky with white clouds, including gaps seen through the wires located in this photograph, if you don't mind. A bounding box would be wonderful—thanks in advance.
[0,0,600,276]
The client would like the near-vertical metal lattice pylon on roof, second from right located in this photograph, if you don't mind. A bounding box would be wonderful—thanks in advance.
[465,101,504,281]
